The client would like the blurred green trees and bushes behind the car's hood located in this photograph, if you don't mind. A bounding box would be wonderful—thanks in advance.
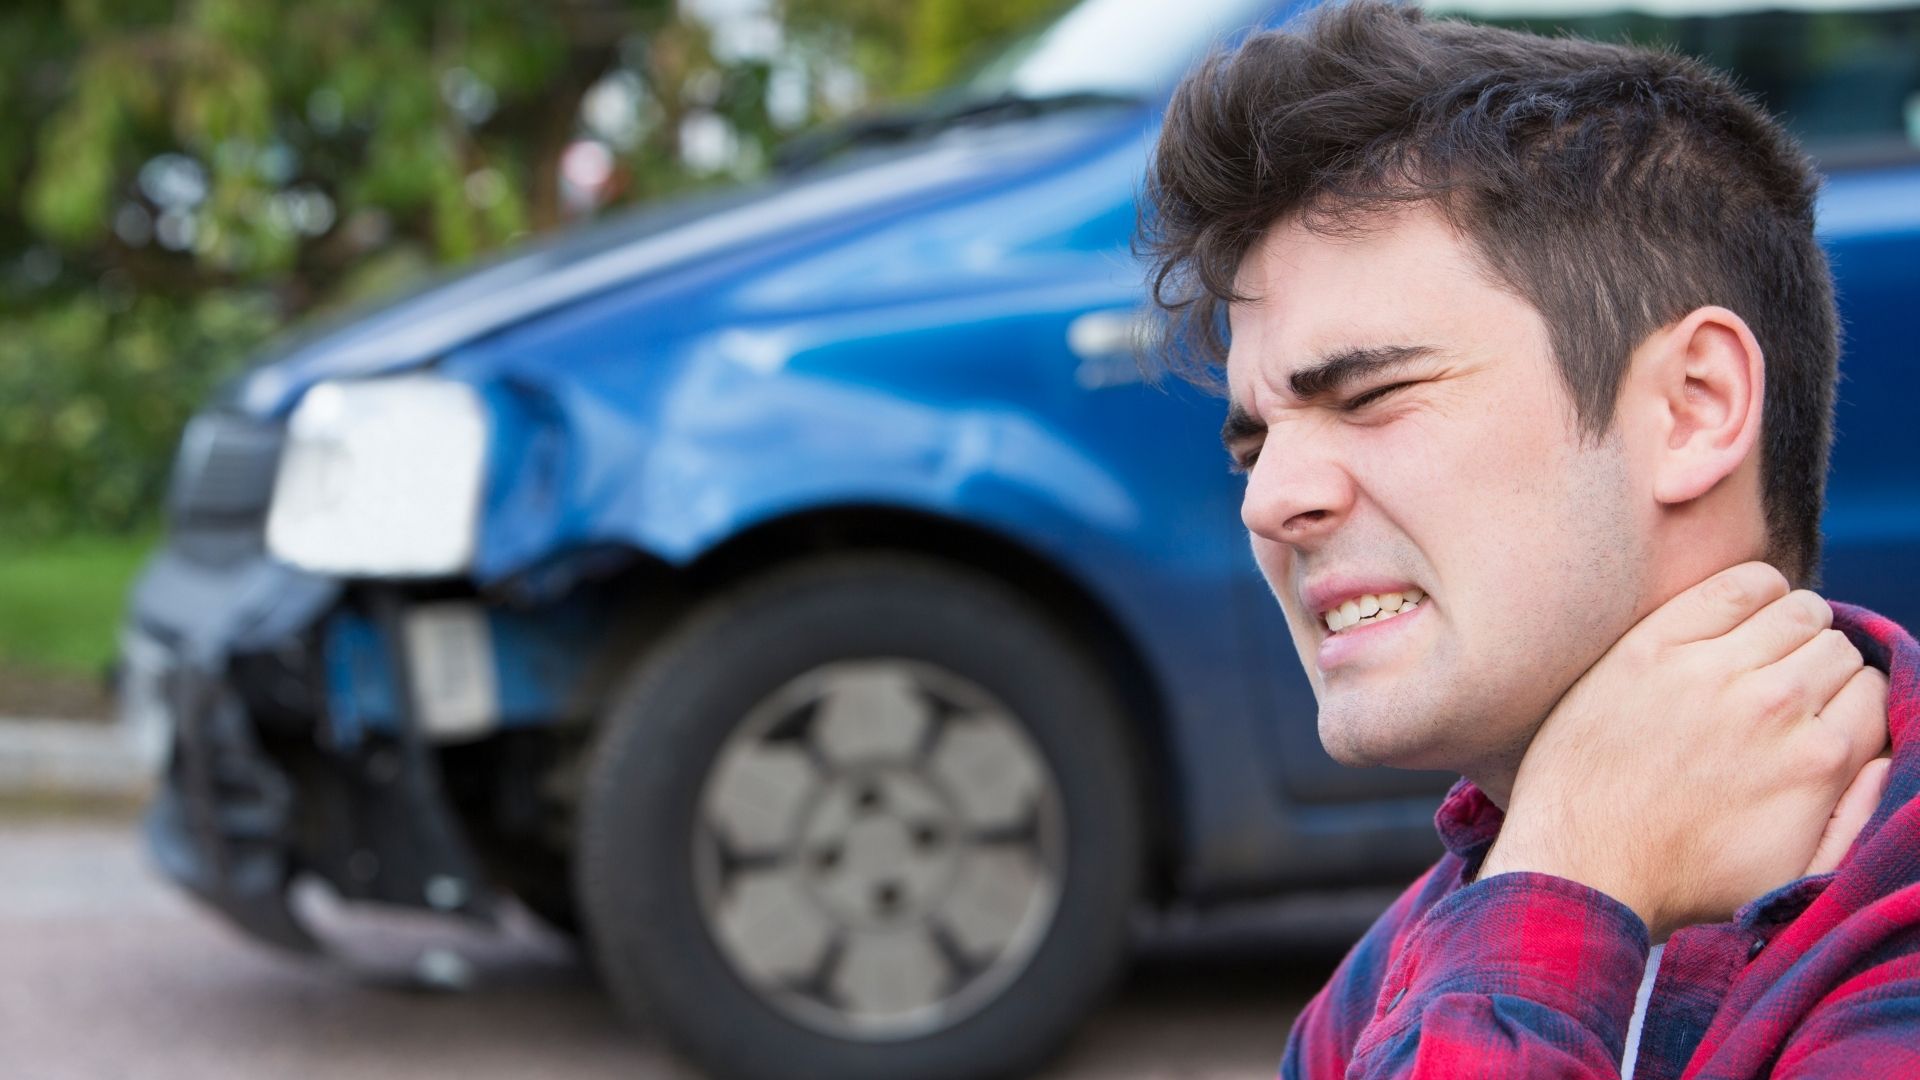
[0,0,1060,536]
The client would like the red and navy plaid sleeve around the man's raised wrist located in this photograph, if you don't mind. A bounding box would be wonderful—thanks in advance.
[1336,872,1647,1080]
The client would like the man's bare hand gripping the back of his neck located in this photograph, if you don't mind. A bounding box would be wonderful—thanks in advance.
[1480,563,1887,942]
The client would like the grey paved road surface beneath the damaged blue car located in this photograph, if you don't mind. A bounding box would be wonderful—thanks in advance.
[0,813,1380,1080]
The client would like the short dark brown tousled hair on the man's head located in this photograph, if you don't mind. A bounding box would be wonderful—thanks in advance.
[1140,0,1839,580]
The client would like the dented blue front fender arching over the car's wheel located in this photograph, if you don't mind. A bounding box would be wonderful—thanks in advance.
[447,305,1344,888]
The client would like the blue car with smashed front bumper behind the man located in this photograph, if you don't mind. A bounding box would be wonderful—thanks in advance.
[123,0,1920,1080]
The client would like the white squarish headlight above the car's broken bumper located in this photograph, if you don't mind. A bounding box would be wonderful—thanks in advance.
[267,375,488,577]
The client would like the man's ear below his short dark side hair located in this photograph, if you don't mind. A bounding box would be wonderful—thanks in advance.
[1632,307,1766,505]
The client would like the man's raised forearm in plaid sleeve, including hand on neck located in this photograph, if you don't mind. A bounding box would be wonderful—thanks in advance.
[1286,565,1885,1076]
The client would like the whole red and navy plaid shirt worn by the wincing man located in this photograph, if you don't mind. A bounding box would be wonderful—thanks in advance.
[1281,603,1920,1080]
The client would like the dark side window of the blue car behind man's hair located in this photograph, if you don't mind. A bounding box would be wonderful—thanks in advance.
[1425,0,1920,167]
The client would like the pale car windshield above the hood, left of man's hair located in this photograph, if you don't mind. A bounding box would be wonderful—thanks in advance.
[962,0,1277,100]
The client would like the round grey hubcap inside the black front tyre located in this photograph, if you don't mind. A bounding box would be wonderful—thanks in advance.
[693,659,1066,1040]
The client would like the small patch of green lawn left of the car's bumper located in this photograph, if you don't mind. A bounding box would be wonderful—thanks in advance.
[0,532,157,676]
